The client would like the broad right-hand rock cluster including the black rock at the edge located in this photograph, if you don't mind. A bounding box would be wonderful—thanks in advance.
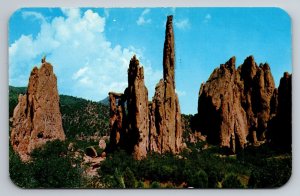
[197,56,292,152]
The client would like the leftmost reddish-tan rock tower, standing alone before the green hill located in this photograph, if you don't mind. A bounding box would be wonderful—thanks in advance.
[11,61,65,161]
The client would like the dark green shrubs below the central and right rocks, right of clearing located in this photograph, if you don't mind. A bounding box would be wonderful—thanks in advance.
[99,142,292,188]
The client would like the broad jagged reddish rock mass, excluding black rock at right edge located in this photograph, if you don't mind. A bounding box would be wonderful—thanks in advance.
[198,56,276,152]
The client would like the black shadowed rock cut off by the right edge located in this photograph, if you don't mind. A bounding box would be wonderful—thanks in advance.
[269,72,292,151]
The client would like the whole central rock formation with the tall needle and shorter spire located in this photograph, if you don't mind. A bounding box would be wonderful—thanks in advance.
[109,16,182,159]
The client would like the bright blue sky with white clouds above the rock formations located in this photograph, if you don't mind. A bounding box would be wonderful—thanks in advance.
[9,8,292,114]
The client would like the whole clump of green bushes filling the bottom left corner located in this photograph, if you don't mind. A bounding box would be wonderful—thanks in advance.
[9,140,83,188]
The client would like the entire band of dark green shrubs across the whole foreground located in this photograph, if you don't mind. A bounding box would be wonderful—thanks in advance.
[9,135,292,188]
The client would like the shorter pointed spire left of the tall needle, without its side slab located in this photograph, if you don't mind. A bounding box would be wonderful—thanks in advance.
[126,56,149,159]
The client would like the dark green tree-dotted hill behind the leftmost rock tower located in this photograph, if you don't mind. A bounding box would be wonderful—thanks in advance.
[9,86,109,138]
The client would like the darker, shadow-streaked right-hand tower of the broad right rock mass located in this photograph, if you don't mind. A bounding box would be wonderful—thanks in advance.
[239,56,275,142]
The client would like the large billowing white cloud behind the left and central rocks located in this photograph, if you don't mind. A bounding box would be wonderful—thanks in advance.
[9,9,162,100]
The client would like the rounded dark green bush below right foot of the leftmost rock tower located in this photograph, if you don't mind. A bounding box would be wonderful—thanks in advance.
[30,140,81,188]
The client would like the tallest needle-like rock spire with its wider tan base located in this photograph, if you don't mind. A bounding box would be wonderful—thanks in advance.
[150,16,182,153]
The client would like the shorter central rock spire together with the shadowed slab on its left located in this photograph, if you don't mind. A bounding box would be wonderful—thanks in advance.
[109,56,149,159]
